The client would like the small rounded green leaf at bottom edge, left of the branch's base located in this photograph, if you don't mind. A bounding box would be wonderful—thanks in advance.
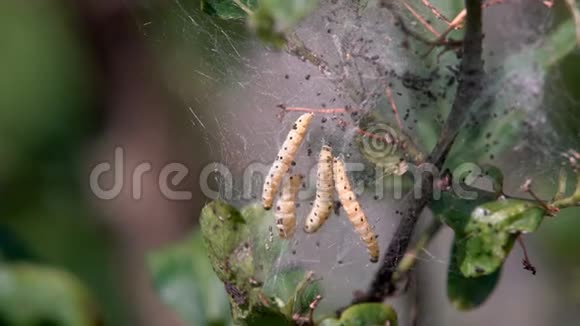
[340,303,397,326]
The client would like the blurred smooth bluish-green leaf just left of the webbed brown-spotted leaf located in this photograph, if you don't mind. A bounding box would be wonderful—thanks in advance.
[147,232,231,326]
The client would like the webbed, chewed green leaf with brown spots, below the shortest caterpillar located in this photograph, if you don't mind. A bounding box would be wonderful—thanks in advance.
[200,201,290,324]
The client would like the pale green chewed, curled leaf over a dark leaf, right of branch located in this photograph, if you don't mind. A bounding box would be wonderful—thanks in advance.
[457,199,544,277]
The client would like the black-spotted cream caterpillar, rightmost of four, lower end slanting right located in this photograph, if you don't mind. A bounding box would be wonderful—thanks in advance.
[333,157,379,263]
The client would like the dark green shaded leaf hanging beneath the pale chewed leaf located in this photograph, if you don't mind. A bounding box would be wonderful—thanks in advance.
[447,237,501,310]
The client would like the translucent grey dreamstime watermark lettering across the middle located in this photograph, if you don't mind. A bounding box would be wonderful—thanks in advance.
[89,147,490,201]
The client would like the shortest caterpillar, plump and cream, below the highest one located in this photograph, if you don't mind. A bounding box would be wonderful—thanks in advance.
[276,175,302,239]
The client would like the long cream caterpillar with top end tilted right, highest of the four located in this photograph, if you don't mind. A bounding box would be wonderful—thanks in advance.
[262,113,314,210]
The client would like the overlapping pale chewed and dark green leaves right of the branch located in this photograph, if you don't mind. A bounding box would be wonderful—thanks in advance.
[430,192,544,310]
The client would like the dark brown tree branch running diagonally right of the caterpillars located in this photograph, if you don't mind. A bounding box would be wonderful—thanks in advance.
[353,0,484,304]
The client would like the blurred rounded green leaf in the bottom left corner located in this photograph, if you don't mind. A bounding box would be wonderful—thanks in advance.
[0,263,100,326]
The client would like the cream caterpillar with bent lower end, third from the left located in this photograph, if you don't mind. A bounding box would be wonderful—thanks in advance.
[304,145,334,233]
